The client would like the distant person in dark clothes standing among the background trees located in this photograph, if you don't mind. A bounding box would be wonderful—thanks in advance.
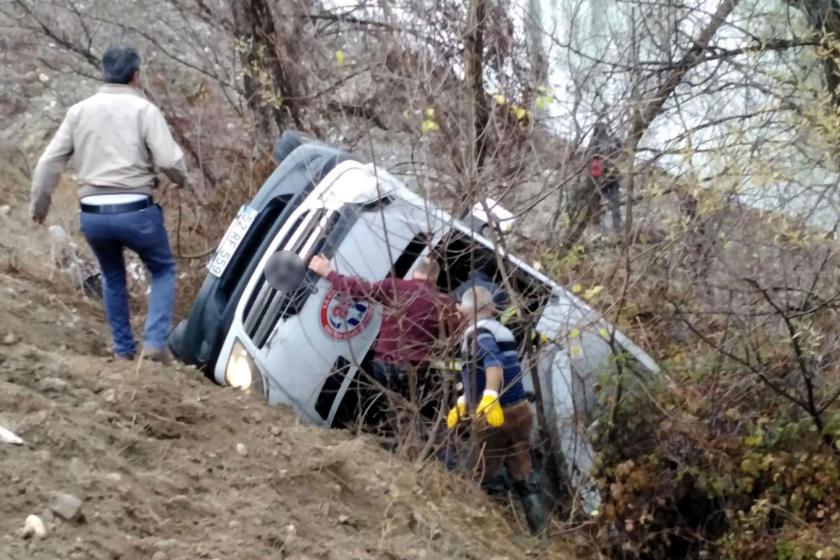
[587,119,621,233]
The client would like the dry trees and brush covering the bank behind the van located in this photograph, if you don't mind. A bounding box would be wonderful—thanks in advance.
[0,0,840,560]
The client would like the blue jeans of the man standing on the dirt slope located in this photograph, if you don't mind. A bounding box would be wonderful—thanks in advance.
[79,205,175,356]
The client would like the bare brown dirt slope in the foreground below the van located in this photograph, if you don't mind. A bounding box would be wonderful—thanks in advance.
[0,171,563,560]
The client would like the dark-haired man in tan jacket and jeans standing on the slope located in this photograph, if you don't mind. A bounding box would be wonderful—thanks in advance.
[30,46,187,361]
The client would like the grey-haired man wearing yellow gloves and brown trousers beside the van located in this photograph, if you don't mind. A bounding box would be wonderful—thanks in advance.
[447,286,548,544]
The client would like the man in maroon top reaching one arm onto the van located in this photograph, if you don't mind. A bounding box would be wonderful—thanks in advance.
[309,255,457,388]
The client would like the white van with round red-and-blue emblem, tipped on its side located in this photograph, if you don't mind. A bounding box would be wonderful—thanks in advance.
[170,134,658,510]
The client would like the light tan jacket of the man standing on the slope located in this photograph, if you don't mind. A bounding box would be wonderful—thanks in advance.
[30,84,187,218]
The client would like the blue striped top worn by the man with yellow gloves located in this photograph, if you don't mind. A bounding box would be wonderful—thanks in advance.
[461,319,525,407]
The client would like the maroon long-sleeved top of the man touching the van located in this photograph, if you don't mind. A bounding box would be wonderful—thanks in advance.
[327,272,457,366]
